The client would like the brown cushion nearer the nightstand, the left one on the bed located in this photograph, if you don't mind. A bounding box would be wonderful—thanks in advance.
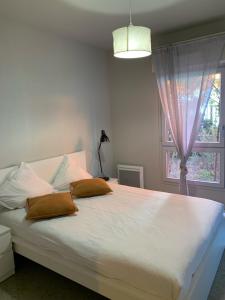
[26,192,78,220]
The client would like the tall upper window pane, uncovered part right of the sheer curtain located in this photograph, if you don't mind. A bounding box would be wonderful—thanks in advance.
[196,73,221,143]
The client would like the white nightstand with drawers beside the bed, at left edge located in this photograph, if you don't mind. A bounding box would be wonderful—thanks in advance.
[0,225,15,282]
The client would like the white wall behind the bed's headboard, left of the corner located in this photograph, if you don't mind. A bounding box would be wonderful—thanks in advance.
[0,19,112,174]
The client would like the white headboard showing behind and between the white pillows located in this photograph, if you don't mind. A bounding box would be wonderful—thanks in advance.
[0,151,87,183]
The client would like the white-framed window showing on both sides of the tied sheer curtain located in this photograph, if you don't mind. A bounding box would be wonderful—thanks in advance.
[163,70,225,187]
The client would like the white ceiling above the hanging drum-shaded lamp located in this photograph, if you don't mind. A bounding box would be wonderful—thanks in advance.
[0,0,225,49]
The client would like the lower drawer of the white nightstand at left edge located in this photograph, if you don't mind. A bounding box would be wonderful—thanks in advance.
[0,250,15,282]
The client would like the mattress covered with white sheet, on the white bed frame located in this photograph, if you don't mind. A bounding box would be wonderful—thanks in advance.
[0,184,224,300]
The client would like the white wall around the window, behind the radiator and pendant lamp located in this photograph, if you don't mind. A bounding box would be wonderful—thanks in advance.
[109,19,225,203]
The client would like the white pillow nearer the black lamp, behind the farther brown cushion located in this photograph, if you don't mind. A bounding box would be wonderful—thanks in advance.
[52,155,92,190]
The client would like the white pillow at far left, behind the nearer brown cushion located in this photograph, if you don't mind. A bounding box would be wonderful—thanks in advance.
[0,162,55,209]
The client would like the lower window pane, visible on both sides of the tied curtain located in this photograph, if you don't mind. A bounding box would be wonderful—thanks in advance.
[166,150,220,183]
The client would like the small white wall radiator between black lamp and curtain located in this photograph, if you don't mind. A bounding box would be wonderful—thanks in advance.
[117,165,144,188]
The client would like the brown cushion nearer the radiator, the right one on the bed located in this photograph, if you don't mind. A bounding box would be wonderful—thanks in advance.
[70,178,112,198]
